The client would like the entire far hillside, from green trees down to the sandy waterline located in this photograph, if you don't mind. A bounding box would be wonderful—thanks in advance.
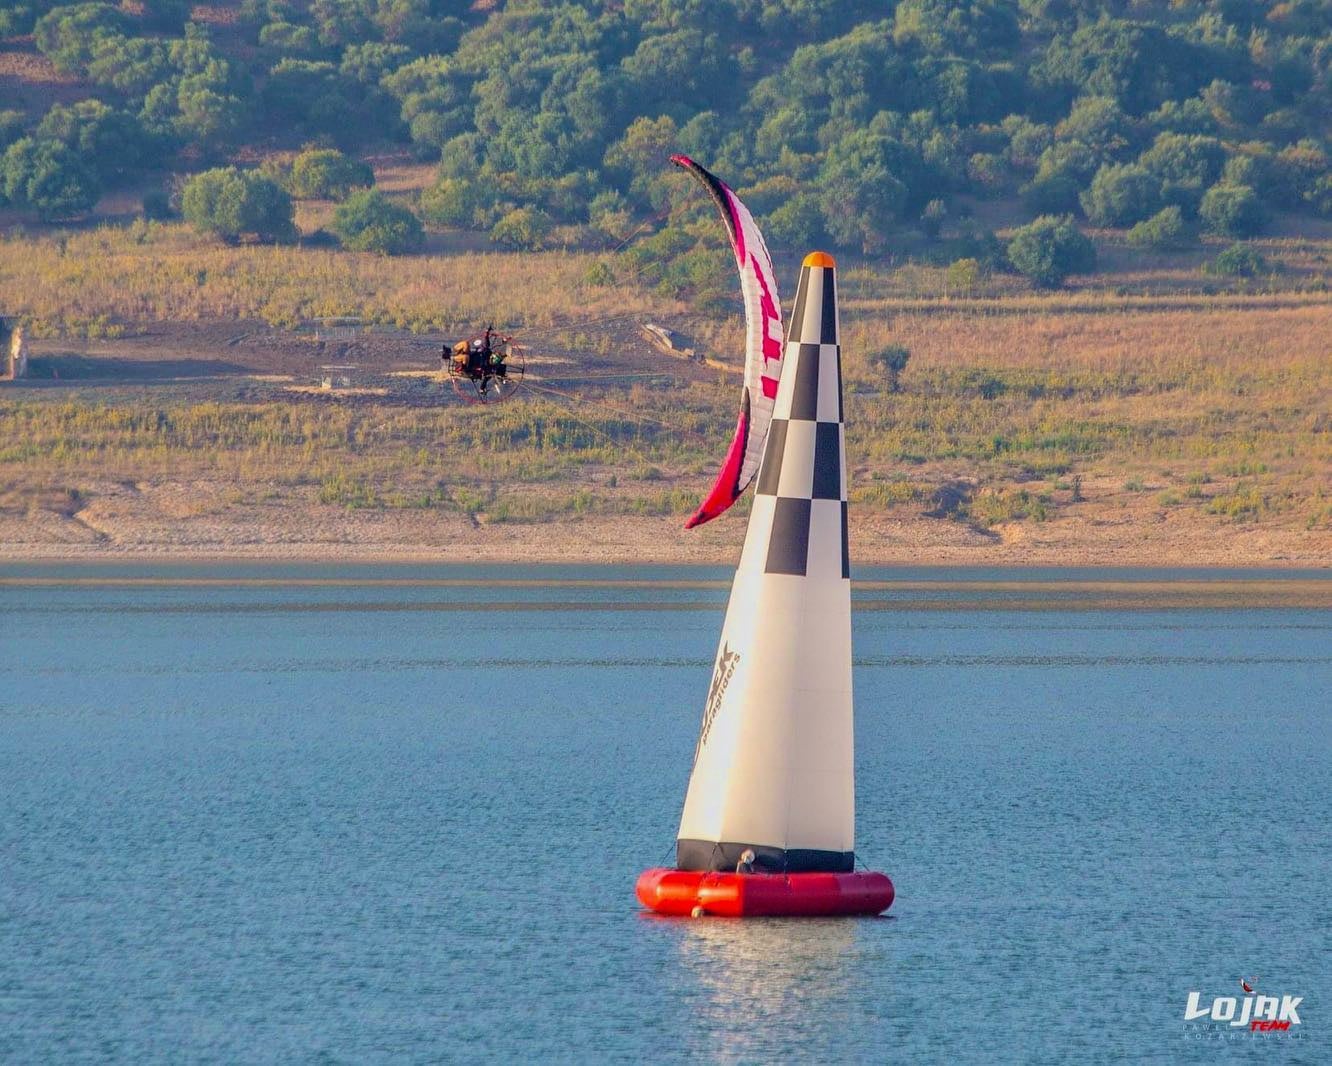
[0,0,1332,565]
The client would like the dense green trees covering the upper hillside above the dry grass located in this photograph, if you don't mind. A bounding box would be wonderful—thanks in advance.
[0,0,1332,258]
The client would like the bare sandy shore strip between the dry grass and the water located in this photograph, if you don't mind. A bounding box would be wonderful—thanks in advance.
[0,485,1332,568]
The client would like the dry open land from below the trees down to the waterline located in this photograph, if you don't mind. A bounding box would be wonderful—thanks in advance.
[0,227,1332,565]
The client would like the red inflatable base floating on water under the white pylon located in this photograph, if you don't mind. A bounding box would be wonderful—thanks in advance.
[635,866,894,918]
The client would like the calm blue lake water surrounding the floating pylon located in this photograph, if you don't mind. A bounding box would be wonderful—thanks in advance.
[0,565,1332,1062]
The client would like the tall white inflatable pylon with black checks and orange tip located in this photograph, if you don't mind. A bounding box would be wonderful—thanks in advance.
[677,255,855,871]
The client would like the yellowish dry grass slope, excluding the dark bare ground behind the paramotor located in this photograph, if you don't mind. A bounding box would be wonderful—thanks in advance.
[0,225,1332,561]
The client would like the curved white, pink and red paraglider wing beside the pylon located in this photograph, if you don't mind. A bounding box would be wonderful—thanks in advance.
[670,156,786,529]
